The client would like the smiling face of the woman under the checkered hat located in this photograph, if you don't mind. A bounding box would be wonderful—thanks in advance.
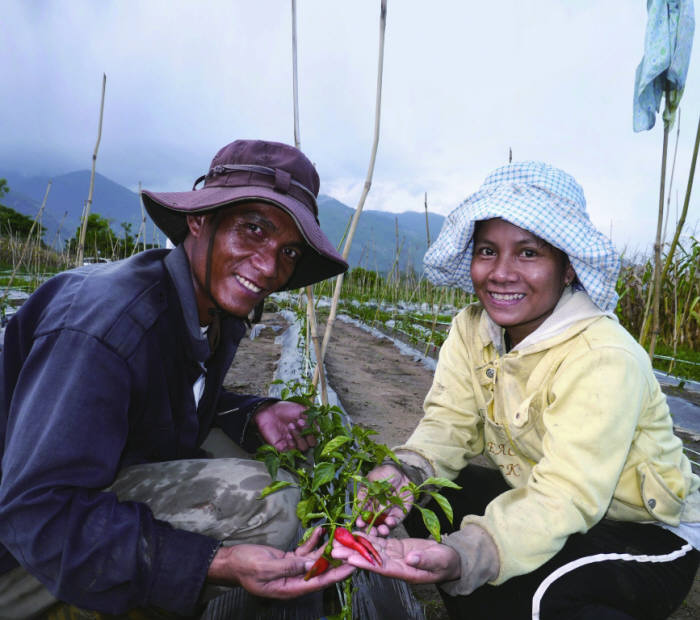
[471,219,576,346]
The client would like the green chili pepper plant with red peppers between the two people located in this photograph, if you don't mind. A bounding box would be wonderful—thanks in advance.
[256,383,459,620]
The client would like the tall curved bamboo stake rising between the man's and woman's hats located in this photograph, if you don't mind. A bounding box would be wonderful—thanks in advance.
[314,0,387,385]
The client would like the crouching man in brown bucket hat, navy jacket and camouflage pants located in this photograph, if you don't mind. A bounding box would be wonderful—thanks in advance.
[0,140,353,618]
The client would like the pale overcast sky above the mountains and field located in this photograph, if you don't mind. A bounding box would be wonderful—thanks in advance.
[0,0,700,252]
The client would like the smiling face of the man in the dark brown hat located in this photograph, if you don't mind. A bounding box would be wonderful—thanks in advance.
[185,202,305,324]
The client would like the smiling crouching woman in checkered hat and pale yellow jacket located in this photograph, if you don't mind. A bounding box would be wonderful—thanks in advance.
[334,162,700,620]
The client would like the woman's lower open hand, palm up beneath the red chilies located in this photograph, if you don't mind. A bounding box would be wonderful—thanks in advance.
[331,536,461,583]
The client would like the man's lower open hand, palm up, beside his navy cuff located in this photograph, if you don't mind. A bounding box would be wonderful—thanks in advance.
[207,528,355,599]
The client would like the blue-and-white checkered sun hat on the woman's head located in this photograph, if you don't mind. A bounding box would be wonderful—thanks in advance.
[423,161,620,312]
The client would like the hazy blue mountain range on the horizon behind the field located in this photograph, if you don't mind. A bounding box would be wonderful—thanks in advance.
[0,170,445,273]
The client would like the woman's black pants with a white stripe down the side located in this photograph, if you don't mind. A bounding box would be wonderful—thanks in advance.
[404,465,700,620]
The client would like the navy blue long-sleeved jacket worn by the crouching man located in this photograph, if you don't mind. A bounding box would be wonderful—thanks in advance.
[0,247,270,613]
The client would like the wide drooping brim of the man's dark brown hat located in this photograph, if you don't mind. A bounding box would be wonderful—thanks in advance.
[141,186,348,290]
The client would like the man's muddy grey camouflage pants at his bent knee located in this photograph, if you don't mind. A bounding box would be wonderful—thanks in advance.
[0,432,299,620]
